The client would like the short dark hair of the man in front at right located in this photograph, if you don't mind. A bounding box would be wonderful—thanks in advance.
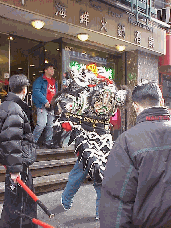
[132,82,162,107]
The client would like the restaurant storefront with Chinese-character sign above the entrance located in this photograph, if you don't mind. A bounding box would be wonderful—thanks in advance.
[0,0,166,130]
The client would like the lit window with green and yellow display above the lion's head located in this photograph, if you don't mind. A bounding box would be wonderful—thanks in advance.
[62,44,122,88]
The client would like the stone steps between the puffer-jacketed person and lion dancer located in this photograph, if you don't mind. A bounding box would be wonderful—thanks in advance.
[0,147,92,203]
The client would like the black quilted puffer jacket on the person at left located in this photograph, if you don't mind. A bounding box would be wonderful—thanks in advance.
[0,92,36,173]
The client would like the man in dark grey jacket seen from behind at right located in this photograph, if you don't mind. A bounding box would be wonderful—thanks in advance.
[99,82,171,228]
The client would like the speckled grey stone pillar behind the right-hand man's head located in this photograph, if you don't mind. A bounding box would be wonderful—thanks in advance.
[121,50,159,131]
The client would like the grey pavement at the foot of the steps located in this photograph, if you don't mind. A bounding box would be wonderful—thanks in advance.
[0,184,100,228]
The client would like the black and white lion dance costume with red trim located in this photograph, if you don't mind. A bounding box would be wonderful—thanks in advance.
[52,68,128,183]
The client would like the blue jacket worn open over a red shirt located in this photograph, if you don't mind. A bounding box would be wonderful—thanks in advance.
[32,76,58,108]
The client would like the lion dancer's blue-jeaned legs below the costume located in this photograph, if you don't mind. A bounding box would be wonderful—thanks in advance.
[61,160,101,220]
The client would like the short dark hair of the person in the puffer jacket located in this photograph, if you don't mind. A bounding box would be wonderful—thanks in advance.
[9,74,30,94]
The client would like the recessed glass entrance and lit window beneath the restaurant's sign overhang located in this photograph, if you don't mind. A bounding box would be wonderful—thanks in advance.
[0,33,122,95]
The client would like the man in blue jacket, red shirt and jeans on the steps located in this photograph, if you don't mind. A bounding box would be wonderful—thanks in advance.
[32,63,58,149]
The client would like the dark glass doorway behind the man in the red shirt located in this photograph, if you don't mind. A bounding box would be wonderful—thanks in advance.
[0,33,61,100]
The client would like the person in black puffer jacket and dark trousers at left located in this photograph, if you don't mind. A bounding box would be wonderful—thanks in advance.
[0,75,37,228]
